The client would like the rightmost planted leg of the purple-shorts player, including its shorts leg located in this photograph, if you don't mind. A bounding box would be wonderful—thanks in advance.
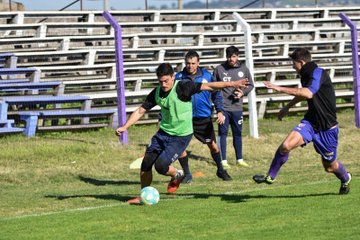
[313,126,351,194]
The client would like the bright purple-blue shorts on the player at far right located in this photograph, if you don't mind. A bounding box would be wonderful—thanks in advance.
[293,119,339,162]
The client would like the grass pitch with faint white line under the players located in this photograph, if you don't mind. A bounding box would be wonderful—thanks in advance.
[0,111,360,239]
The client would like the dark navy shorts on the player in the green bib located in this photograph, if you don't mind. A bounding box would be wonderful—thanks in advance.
[146,129,192,165]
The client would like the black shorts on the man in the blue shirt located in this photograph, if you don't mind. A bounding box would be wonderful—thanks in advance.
[193,117,216,143]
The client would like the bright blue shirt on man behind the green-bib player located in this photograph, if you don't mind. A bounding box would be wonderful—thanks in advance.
[175,68,223,117]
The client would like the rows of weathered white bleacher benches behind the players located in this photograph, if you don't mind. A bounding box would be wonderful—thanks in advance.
[0,7,360,135]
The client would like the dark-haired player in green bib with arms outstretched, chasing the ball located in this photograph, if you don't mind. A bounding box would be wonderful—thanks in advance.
[116,63,248,203]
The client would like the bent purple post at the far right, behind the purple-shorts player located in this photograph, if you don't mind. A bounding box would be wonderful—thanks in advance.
[339,13,360,128]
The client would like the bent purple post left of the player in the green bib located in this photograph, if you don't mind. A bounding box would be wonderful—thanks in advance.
[103,11,128,143]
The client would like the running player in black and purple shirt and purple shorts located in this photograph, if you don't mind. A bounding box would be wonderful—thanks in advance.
[253,48,351,194]
